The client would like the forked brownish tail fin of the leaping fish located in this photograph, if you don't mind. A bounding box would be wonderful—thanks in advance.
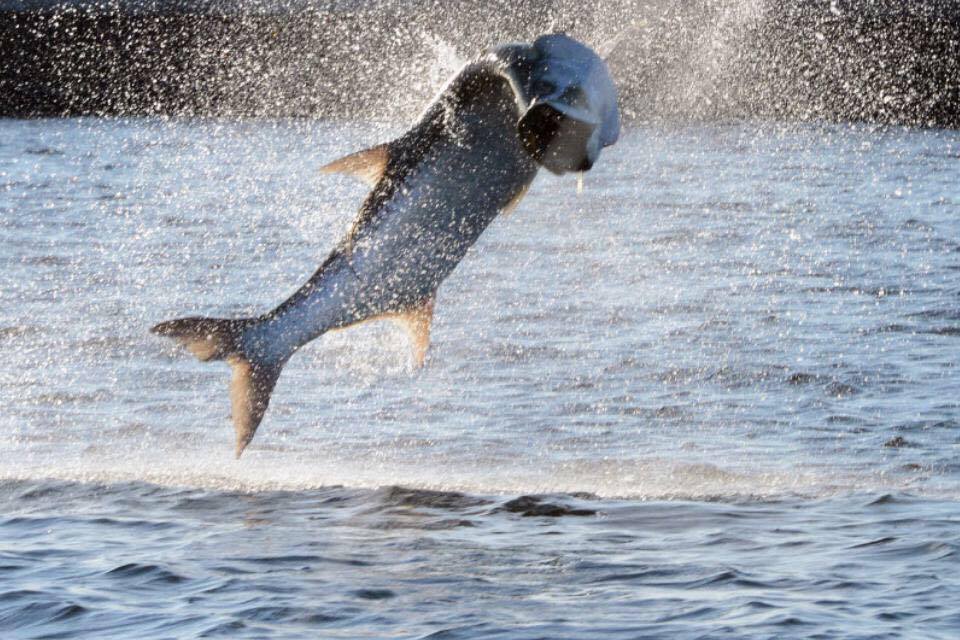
[151,317,285,458]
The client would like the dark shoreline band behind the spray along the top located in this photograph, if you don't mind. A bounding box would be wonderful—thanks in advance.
[0,0,960,128]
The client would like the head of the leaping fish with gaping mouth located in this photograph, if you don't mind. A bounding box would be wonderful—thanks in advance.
[517,33,620,175]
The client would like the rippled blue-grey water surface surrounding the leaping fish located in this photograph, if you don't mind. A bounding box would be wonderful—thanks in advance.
[0,119,960,639]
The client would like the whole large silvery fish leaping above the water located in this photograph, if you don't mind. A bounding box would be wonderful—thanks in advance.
[152,34,620,458]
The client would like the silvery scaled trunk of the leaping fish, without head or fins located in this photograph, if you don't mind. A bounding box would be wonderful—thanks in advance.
[246,75,538,358]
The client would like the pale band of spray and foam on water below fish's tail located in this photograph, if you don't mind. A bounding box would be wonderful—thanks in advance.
[0,450,944,500]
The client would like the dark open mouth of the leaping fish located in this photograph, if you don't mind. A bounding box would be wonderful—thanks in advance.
[517,102,597,175]
